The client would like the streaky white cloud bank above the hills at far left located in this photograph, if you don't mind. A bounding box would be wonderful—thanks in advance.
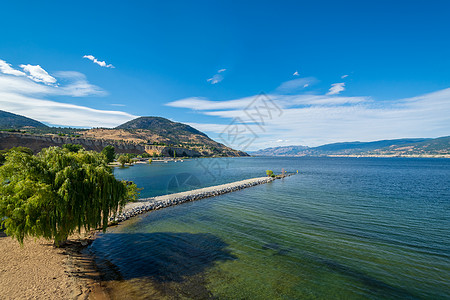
[0,61,135,127]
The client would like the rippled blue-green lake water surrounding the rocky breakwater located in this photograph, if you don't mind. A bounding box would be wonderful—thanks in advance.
[89,158,450,299]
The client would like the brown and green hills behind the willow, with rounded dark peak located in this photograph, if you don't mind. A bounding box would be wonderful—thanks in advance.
[0,111,248,156]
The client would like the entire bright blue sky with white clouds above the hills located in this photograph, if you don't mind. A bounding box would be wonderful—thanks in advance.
[0,0,450,150]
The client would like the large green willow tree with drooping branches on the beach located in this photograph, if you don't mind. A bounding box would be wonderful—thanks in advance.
[0,147,137,246]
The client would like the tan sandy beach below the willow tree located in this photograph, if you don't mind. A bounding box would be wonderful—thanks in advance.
[0,232,108,299]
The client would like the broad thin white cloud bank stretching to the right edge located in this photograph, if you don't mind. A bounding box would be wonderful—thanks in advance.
[167,88,450,150]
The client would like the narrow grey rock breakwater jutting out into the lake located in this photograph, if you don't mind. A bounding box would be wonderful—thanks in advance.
[109,177,275,223]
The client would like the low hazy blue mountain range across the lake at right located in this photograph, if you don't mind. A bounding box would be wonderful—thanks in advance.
[250,136,450,157]
